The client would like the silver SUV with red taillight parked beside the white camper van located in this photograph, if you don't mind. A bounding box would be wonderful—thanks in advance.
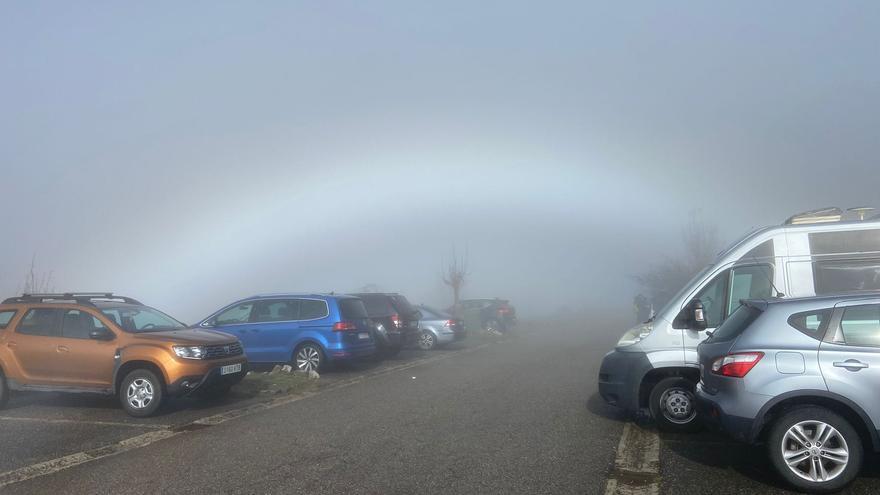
[696,292,880,493]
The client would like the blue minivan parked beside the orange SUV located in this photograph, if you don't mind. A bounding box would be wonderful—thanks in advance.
[198,294,376,371]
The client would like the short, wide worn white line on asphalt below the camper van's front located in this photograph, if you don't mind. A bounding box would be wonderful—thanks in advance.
[605,423,660,495]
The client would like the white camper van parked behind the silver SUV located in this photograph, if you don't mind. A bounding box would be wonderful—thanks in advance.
[599,208,880,431]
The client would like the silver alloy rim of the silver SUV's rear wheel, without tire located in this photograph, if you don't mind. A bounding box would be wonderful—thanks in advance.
[780,421,849,482]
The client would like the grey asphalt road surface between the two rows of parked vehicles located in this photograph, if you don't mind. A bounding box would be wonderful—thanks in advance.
[0,322,880,494]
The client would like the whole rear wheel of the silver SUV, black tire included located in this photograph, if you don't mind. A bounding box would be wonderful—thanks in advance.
[767,406,864,493]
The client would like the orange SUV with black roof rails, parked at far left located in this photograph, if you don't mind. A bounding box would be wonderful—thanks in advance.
[0,293,247,417]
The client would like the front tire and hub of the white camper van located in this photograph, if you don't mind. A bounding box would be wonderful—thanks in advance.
[648,376,702,433]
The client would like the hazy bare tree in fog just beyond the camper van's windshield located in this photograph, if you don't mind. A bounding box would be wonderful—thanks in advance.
[635,212,719,308]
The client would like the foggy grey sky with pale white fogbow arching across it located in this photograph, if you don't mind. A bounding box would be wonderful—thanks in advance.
[0,0,880,321]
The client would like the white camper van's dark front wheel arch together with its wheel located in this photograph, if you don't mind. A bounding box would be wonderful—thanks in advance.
[639,368,701,433]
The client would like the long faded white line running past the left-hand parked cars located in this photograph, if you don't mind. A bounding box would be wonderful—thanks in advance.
[0,343,489,488]
